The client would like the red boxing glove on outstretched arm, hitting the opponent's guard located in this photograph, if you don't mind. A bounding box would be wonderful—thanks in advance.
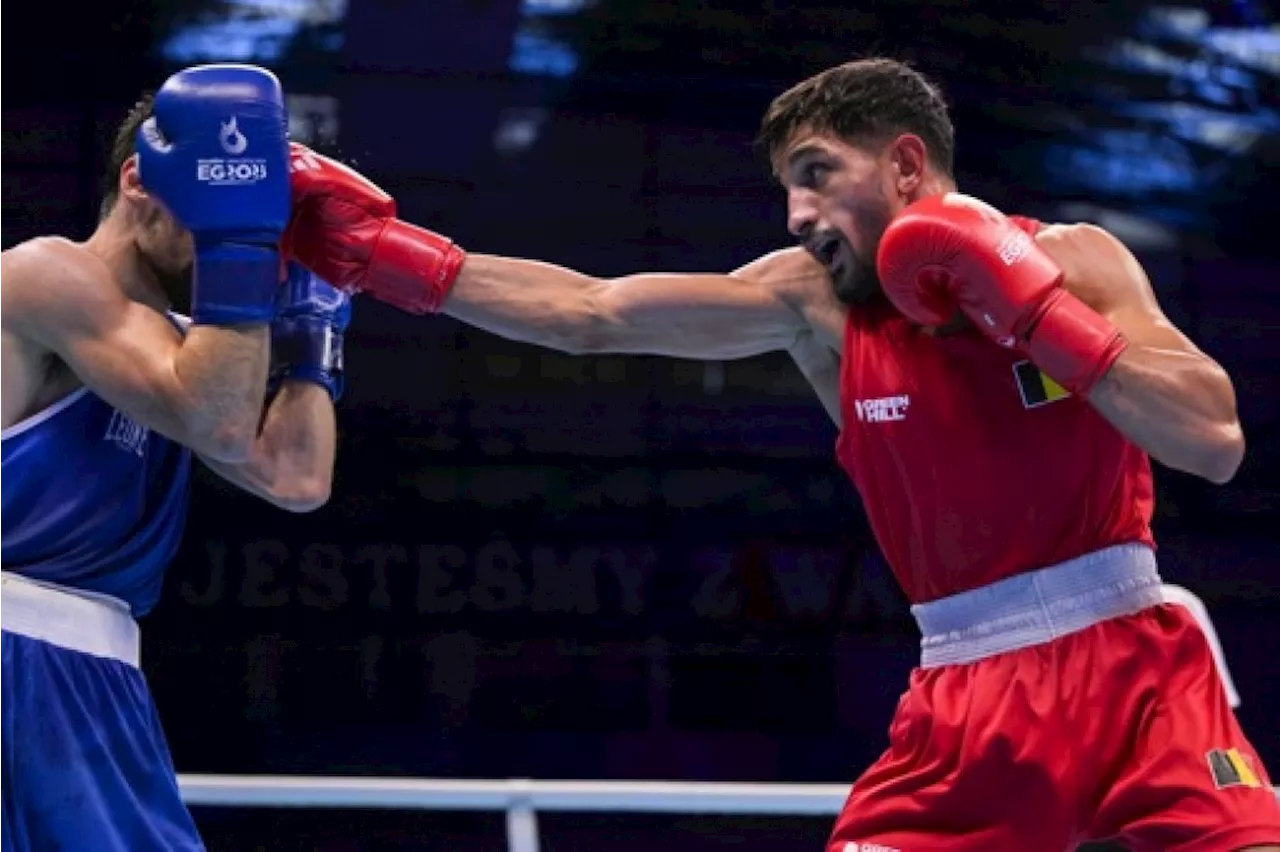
[280,143,466,313]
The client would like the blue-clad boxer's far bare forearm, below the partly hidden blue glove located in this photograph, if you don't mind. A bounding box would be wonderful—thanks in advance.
[201,380,338,512]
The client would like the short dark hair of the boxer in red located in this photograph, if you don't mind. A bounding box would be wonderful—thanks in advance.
[759,59,956,175]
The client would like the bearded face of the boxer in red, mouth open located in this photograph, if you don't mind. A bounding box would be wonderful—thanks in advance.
[773,129,924,304]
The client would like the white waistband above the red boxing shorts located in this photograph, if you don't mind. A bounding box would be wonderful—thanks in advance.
[911,544,1164,669]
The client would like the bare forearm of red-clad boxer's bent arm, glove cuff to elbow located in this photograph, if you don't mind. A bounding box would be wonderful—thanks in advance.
[1089,345,1244,484]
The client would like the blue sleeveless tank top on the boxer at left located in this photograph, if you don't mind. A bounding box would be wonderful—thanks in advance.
[0,388,191,617]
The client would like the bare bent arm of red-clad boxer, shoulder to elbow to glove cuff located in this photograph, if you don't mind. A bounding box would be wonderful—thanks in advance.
[1038,225,1244,484]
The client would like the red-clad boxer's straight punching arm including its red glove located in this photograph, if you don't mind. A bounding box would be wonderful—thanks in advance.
[284,145,840,359]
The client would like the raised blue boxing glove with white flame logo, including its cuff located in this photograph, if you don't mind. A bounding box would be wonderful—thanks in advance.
[136,65,291,325]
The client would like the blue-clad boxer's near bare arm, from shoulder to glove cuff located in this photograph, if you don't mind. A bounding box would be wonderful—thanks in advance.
[0,239,269,461]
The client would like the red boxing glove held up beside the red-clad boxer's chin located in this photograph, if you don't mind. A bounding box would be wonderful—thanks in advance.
[876,193,1128,397]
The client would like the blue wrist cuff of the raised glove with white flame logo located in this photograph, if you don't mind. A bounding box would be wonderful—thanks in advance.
[191,243,280,325]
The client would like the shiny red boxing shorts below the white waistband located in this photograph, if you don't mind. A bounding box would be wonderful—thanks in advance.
[827,605,1280,852]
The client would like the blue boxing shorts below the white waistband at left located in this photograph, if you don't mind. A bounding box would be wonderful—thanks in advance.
[0,629,205,852]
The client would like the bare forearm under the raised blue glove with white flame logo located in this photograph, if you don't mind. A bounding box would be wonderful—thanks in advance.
[174,325,270,462]
